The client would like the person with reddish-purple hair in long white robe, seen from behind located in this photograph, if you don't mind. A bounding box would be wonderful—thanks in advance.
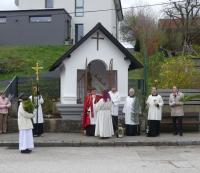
[95,91,114,138]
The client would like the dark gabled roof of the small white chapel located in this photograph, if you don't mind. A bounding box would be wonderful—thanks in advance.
[49,23,143,71]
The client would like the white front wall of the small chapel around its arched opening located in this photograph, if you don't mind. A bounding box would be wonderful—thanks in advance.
[61,30,130,104]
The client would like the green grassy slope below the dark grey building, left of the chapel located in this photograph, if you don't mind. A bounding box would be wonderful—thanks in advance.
[0,45,70,80]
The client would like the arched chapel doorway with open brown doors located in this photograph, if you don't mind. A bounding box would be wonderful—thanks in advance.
[77,59,117,104]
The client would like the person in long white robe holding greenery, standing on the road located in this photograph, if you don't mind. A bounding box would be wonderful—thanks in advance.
[18,96,34,153]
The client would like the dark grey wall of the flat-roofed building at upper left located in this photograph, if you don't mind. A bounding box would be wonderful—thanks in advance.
[0,10,71,45]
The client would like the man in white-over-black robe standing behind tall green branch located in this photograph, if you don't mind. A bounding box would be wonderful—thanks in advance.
[123,88,141,136]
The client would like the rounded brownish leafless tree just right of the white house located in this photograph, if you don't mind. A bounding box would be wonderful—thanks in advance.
[121,9,161,55]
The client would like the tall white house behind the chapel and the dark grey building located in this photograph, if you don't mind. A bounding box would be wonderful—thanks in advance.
[15,0,123,43]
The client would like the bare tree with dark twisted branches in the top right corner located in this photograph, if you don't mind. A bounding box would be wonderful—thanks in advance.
[165,0,200,48]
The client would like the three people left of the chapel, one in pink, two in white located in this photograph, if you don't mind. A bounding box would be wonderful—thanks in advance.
[0,87,44,153]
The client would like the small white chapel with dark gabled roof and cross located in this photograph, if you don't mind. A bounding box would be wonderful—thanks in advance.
[50,23,143,104]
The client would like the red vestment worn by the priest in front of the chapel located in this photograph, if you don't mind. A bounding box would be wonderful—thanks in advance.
[82,95,102,129]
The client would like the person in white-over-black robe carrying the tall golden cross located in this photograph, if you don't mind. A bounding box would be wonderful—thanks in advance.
[29,87,44,137]
